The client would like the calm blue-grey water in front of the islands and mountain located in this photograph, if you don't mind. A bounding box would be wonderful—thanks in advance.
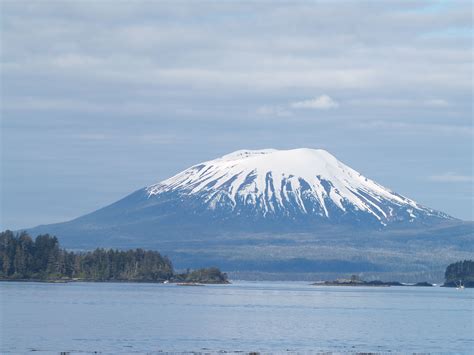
[0,282,474,353]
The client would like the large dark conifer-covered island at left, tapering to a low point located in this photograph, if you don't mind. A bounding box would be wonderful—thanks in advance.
[0,230,228,284]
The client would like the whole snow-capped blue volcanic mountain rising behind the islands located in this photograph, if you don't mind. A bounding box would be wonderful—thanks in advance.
[26,149,472,280]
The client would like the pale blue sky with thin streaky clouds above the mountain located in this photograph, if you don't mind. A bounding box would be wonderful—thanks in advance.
[0,0,474,230]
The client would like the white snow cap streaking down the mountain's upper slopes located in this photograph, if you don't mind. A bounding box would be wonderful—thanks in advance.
[146,149,451,225]
